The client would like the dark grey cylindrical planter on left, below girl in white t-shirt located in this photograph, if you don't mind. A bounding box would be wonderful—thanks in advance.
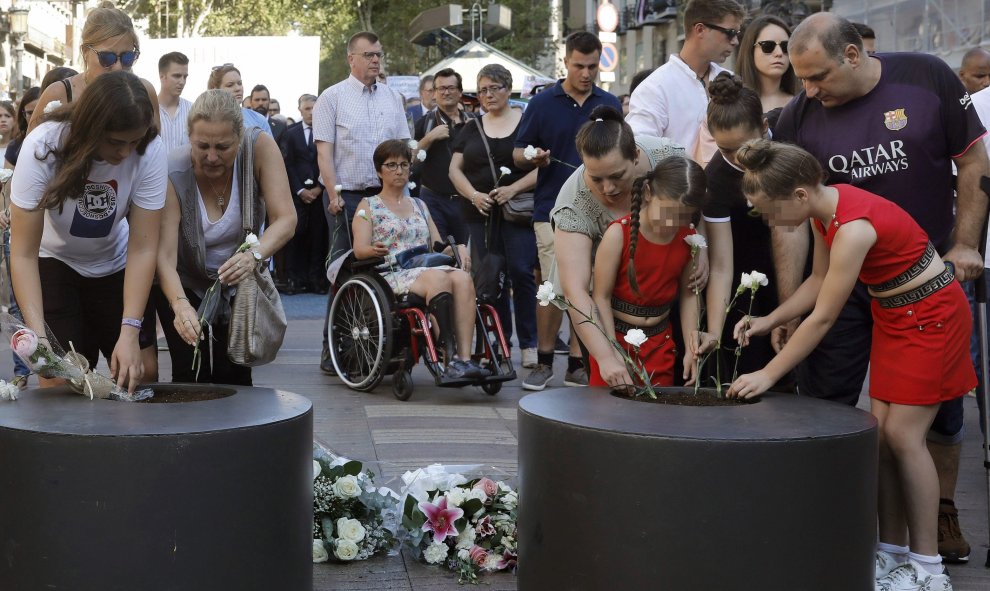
[0,385,313,591]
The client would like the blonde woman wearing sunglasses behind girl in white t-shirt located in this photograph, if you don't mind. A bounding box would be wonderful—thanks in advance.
[28,1,161,131]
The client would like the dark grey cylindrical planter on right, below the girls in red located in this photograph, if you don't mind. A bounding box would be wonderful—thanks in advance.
[518,388,877,591]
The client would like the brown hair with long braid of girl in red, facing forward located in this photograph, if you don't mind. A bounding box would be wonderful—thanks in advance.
[626,156,707,295]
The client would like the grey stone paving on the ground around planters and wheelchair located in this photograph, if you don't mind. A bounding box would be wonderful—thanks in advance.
[0,295,990,591]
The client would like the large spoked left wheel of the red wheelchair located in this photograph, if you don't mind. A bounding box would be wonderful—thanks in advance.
[329,275,393,392]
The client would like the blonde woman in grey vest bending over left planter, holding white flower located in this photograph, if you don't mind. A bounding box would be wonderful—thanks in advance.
[153,90,296,386]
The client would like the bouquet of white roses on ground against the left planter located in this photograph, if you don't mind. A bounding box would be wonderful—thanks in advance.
[313,442,399,562]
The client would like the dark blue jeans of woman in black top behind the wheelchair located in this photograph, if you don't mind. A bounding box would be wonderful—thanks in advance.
[468,217,537,349]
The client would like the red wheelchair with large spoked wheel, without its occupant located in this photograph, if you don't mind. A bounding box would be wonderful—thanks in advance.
[328,253,516,400]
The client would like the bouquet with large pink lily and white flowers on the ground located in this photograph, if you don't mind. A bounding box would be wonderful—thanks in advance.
[402,464,519,583]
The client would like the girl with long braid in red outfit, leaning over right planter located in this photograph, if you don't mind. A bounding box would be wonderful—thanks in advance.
[589,156,714,388]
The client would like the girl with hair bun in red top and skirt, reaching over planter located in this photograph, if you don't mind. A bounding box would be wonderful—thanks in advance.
[728,140,976,591]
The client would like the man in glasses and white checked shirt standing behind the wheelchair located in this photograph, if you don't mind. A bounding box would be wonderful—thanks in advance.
[313,31,409,372]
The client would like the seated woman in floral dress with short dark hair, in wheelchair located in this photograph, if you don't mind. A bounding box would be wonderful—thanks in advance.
[352,140,489,378]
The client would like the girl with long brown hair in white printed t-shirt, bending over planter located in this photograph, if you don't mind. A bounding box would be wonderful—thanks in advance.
[10,72,166,390]
